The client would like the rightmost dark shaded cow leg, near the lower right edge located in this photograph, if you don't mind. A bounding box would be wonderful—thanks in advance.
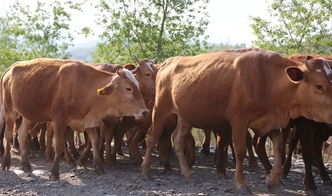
[314,134,332,184]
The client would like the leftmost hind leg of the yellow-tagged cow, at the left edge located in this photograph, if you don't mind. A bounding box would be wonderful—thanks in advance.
[2,118,15,171]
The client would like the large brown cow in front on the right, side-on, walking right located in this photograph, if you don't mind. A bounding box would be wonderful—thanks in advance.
[141,49,332,192]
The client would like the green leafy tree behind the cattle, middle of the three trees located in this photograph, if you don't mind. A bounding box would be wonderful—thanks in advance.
[93,0,209,63]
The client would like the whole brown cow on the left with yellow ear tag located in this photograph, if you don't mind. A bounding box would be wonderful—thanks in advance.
[1,58,149,180]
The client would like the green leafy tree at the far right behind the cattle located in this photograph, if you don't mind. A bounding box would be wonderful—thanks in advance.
[251,0,332,55]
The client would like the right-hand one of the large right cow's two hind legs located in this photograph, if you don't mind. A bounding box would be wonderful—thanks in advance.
[173,117,192,177]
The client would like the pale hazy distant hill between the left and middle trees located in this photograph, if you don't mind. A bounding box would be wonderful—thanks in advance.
[68,40,97,63]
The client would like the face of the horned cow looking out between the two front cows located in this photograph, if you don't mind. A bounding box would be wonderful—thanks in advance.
[132,57,157,99]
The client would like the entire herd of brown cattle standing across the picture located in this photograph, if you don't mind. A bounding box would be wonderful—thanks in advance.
[0,48,332,194]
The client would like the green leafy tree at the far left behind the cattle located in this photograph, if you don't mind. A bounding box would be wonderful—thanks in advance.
[0,1,81,70]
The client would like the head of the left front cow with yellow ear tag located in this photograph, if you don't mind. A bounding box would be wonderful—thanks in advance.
[97,69,149,119]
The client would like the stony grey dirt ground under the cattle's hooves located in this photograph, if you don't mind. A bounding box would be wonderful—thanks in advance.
[0,146,332,196]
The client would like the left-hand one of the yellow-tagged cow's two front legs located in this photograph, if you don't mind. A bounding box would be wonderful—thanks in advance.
[50,120,66,180]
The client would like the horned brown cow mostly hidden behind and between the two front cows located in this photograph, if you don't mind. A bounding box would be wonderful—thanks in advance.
[79,57,158,165]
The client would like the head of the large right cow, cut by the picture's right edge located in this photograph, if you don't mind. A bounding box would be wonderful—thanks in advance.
[286,56,332,123]
